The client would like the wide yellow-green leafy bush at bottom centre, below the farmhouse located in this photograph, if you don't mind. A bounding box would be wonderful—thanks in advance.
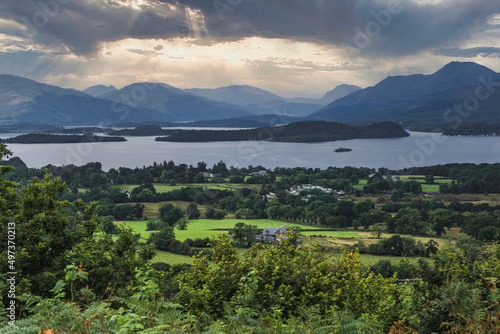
[177,236,403,327]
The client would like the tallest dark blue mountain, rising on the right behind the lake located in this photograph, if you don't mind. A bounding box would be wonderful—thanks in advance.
[305,62,500,126]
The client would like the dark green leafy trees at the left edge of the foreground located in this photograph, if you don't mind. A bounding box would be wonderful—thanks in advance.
[0,146,155,310]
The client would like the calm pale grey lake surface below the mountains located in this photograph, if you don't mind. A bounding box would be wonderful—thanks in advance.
[0,132,500,170]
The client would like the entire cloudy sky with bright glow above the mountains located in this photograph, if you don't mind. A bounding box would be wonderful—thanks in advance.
[0,0,500,97]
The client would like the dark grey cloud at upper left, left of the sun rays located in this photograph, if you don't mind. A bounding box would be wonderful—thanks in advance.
[0,0,189,55]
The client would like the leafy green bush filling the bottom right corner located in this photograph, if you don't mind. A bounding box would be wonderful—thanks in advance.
[409,245,500,333]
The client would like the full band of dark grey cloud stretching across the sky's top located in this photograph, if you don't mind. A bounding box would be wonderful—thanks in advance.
[0,0,500,56]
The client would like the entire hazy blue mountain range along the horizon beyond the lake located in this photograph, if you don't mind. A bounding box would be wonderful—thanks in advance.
[0,62,500,128]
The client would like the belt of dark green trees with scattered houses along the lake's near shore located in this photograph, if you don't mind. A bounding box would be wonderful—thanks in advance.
[5,158,500,241]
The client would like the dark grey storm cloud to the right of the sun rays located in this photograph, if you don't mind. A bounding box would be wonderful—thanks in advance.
[178,0,500,56]
